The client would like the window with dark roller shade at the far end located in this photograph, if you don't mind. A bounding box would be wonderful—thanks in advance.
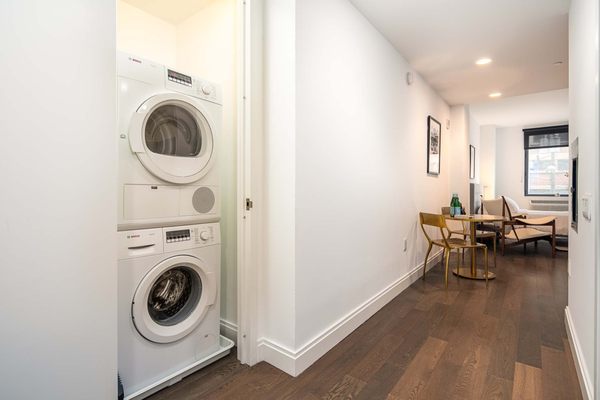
[523,125,569,196]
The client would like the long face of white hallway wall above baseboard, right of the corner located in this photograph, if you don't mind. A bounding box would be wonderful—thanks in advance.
[295,0,450,347]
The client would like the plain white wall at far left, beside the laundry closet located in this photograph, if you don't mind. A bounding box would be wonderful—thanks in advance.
[0,0,117,400]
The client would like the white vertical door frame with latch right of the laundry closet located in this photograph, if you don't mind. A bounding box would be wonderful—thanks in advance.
[236,0,264,365]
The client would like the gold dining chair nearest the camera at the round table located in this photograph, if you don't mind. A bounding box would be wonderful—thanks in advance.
[419,212,488,288]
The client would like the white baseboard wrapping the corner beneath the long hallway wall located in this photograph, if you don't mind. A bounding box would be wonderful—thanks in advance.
[258,250,443,376]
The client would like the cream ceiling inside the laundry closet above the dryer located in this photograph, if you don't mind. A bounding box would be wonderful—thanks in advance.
[123,0,214,25]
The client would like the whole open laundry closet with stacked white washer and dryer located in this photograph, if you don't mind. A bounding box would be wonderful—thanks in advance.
[116,0,238,399]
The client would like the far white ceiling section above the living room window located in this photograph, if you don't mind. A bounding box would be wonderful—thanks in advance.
[469,89,569,127]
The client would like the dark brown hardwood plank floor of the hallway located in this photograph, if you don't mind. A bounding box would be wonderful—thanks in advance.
[151,243,581,400]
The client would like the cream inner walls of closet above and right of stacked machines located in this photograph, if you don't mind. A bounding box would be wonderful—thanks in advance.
[117,0,238,333]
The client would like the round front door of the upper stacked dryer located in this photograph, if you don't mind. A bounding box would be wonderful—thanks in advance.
[129,93,214,184]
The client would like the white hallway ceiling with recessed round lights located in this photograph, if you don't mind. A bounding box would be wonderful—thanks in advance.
[350,0,569,105]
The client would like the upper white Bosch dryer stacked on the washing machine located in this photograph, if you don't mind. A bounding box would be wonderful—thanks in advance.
[117,53,222,230]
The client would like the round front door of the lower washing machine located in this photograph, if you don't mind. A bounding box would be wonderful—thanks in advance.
[131,256,216,343]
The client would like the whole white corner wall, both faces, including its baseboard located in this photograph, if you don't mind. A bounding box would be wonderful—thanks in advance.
[259,0,450,374]
